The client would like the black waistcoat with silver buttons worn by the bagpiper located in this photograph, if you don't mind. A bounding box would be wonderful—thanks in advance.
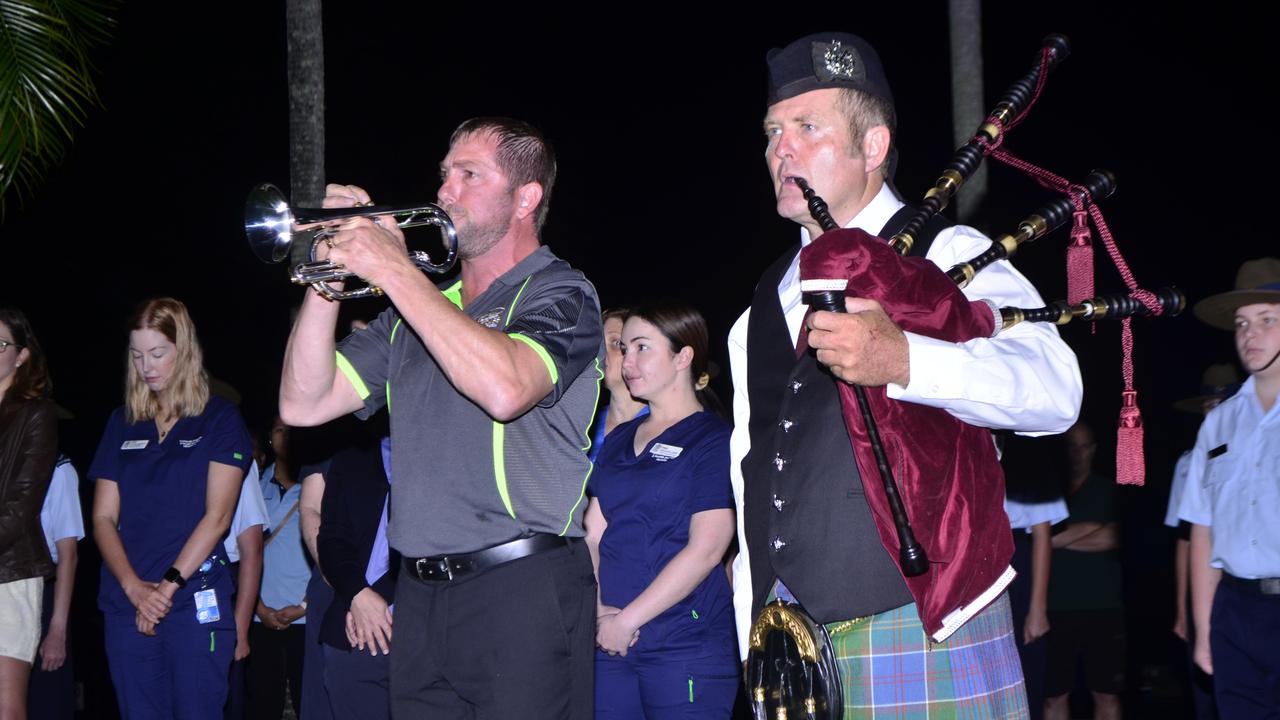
[742,209,945,623]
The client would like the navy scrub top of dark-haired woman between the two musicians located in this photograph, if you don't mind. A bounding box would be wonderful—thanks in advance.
[589,411,736,664]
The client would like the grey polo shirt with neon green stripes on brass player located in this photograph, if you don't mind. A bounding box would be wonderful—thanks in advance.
[338,246,604,557]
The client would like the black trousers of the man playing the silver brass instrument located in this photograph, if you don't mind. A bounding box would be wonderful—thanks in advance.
[390,541,595,720]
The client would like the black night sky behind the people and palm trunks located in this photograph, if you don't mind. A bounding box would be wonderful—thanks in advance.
[0,0,1277,707]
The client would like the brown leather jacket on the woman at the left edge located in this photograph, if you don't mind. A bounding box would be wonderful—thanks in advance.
[0,398,58,583]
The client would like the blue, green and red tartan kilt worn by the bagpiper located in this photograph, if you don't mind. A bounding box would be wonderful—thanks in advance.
[827,593,1028,720]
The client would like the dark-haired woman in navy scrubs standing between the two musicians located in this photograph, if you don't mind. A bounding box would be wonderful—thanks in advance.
[586,302,739,719]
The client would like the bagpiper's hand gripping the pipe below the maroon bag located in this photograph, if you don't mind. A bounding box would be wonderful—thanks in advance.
[805,297,911,387]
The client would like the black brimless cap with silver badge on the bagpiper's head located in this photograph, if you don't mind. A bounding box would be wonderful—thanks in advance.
[765,32,893,108]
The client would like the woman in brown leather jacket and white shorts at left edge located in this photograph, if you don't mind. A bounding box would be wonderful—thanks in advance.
[0,307,58,720]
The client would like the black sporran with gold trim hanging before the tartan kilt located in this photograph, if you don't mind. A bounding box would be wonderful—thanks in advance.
[746,600,845,720]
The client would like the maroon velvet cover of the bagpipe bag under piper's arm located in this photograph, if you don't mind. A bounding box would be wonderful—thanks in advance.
[800,229,1014,634]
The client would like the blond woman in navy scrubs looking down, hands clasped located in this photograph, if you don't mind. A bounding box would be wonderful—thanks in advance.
[90,299,252,720]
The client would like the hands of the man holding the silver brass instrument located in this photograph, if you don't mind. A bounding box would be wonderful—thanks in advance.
[296,183,412,286]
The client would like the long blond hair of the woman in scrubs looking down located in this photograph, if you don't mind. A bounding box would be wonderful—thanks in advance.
[124,297,209,423]
